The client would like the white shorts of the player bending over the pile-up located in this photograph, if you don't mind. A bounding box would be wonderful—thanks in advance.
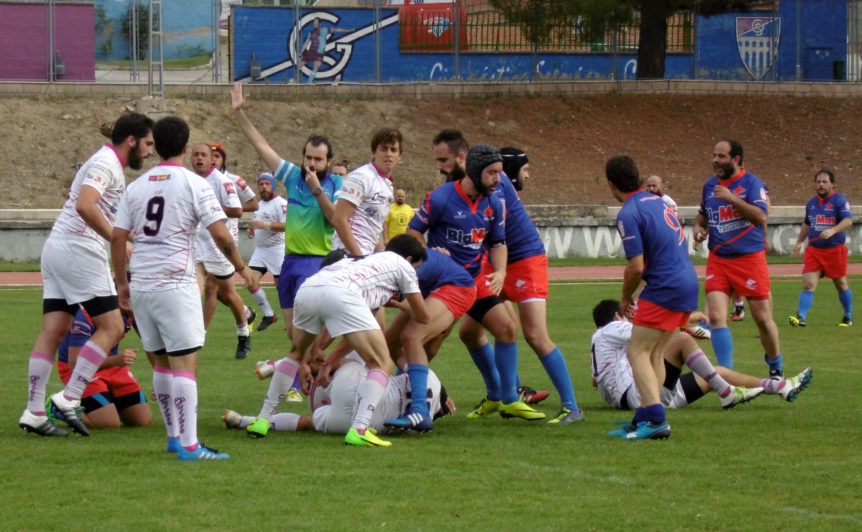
[293,284,380,338]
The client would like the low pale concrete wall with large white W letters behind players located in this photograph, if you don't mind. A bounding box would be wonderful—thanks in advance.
[5,205,862,261]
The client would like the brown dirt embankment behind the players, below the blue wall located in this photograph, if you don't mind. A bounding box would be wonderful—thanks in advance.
[0,92,862,208]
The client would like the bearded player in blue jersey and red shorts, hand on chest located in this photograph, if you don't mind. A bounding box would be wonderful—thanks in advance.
[694,140,784,379]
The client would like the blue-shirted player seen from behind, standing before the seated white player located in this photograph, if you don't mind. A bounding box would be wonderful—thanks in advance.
[605,155,704,440]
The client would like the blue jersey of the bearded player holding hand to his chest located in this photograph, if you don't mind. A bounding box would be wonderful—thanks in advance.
[700,168,769,258]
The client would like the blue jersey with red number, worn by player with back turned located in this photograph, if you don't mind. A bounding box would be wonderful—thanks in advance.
[617,189,698,312]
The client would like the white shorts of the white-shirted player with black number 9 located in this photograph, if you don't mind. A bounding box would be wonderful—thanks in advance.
[131,284,206,353]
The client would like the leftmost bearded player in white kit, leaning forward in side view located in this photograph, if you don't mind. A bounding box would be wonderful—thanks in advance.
[18,113,153,436]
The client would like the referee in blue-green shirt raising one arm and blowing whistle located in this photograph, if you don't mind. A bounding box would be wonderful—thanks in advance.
[231,83,350,338]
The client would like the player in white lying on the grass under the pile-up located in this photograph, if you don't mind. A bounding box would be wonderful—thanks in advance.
[222,351,455,434]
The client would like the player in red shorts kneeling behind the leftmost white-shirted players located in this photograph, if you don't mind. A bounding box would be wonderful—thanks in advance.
[53,308,153,429]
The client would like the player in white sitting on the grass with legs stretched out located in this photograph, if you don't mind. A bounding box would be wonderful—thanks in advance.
[591,299,812,410]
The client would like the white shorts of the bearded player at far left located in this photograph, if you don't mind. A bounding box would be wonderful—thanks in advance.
[41,236,117,305]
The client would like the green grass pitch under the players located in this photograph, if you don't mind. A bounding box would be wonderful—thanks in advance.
[0,279,862,531]
